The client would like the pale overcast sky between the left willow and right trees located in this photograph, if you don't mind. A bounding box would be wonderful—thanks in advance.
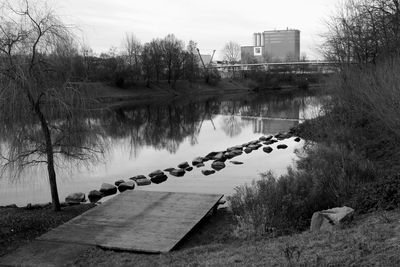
[53,0,340,59]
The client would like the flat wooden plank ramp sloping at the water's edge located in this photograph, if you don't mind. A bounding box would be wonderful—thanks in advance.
[38,191,223,253]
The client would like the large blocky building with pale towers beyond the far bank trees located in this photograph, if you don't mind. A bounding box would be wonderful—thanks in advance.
[241,29,300,63]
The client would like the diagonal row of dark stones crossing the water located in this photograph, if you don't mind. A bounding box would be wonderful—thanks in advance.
[76,133,301,202]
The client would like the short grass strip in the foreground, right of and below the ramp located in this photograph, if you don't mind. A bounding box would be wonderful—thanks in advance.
[70,210,400,266]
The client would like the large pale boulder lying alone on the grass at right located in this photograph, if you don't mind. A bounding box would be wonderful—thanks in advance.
[310,206,354,232]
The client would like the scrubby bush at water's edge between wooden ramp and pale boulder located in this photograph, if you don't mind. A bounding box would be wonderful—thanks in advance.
[228,145,376,238]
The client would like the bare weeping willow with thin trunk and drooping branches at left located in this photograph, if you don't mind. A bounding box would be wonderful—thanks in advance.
[0,0,103,211]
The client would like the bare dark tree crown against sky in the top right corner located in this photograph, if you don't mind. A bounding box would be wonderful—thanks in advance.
[324,0,400,64]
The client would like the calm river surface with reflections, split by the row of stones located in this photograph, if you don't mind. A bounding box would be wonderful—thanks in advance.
[0,91,319,205]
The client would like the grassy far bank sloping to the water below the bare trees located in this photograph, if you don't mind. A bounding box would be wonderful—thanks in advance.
[73,79,321,107]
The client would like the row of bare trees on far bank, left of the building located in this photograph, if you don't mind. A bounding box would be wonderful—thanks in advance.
[72,34,204,88]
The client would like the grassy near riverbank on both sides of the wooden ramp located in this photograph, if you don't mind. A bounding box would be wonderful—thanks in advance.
[0,205,400,266]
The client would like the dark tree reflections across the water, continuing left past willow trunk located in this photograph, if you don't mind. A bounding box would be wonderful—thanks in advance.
[0,90,318,180]
